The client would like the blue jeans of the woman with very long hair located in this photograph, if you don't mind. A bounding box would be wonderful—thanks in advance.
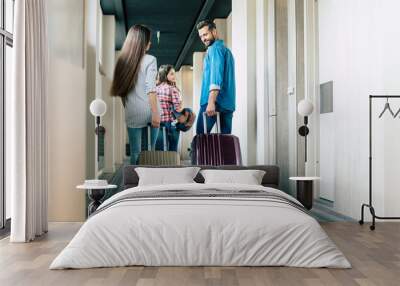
[128,127,159,165]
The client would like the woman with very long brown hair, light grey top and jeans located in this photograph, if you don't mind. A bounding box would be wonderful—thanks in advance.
[111,25,160,165]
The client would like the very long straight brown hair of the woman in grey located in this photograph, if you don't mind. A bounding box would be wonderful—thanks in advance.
[111,25,151,102]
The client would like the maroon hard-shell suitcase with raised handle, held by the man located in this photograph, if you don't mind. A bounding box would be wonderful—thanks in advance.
[191,113,242,166]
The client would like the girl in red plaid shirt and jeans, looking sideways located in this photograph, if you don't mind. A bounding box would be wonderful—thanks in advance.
[156,65,182,151]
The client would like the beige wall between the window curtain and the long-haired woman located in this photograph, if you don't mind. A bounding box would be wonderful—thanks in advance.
[48,0,120,221]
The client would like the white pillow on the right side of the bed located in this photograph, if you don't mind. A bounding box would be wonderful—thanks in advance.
[200,170,265,185]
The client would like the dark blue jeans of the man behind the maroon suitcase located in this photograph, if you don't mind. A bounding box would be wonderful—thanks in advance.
[196,105,233,134]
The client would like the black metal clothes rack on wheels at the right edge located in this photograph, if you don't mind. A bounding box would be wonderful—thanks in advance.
[359,95,400,230]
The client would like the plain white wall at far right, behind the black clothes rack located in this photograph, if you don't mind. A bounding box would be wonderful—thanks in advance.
[318,0,400,218]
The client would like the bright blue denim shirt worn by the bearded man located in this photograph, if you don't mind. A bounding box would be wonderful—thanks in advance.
[200,40,236,111]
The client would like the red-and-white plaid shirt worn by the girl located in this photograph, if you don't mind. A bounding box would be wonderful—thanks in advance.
[156,82,182,122]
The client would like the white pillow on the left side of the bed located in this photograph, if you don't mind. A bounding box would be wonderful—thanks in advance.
[135,167,200,186]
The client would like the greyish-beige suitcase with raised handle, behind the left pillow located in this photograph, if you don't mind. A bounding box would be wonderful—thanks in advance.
[139,126,181,166]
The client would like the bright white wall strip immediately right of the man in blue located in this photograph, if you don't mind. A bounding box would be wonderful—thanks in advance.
[232,0,257,165]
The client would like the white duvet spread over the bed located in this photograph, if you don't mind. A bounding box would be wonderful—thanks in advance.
[50,184,351,269]
